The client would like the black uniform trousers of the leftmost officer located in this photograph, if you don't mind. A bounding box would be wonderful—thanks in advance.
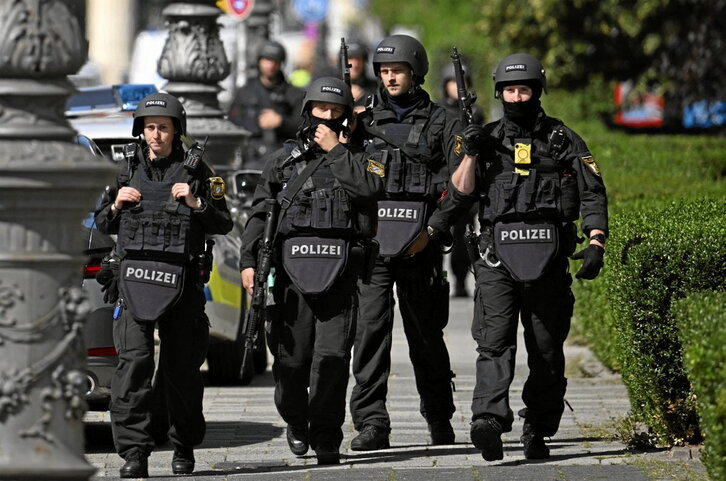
[110,279,209,458]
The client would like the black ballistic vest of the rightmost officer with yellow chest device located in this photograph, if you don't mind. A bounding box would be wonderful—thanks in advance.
[479,118,580,224]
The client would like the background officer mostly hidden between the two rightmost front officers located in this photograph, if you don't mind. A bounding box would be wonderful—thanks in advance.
[438,58,484,297]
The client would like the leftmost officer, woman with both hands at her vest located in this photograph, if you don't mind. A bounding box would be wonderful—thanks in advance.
[95,93,232,478]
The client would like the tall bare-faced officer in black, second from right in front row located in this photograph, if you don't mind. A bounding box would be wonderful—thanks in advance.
[350,35,461,451]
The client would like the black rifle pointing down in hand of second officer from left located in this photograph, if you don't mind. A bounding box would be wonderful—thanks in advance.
[240,199,280,376]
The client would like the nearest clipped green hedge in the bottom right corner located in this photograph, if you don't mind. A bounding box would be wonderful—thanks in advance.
[673,291,726,480]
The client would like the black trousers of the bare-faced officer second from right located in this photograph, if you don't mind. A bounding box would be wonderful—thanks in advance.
[350,244,455,431]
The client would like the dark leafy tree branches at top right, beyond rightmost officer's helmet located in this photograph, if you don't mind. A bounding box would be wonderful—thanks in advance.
[477,0,726,109]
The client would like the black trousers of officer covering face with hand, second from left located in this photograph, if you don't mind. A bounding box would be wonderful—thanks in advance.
[268,268,358,449]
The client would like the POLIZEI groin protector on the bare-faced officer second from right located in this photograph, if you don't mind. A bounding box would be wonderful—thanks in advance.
[376,200,426,257]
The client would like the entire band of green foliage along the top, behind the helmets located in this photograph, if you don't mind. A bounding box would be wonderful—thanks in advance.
[371,0,726,113]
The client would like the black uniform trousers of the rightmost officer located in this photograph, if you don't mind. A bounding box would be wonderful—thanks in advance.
[471,256,574,436]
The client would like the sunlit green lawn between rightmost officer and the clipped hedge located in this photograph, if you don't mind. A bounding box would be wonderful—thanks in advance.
[572,111,726,370]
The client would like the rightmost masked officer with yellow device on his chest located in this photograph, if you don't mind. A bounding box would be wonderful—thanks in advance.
[430,53,608,461]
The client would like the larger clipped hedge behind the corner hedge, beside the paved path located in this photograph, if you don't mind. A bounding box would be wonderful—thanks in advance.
[575,200,726,444]
